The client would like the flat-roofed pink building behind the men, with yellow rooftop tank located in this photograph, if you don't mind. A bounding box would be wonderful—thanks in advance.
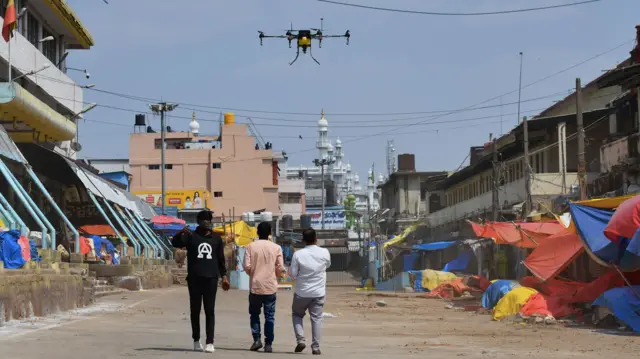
[129,114,279,217]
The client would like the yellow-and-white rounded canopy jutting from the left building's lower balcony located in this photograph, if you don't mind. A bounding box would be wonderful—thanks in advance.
[0,82,76,142]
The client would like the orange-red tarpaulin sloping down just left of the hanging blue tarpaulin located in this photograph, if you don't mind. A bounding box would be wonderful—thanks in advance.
[524,232,584,281]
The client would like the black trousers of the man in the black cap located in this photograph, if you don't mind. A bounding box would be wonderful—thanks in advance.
[187,277,218,344]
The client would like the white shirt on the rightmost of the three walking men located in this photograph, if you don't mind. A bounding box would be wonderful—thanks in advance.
[291,246,331,298]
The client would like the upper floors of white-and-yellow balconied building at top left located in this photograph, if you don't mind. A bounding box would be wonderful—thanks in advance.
[0,0,93,157]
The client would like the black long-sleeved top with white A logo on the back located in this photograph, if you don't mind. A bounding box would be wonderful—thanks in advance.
[171,227,227,278]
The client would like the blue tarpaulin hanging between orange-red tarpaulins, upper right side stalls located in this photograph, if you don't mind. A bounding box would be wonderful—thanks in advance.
[569,203,621,265]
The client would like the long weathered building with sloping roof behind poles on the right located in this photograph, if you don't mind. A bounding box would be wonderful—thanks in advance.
[427,69,620,235]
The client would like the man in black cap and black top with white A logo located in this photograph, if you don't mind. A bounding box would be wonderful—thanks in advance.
[171,210,230,353]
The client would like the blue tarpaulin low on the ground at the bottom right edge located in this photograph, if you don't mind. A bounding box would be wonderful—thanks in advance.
[593,285,640,333]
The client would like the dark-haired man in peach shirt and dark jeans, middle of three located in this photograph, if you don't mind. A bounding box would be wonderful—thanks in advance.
[243,222,285,353]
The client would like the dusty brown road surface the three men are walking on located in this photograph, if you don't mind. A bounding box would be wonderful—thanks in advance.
[0,287,640,359]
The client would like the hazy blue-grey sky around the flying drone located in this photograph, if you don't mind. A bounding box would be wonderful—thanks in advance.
[67,0,640,180]
